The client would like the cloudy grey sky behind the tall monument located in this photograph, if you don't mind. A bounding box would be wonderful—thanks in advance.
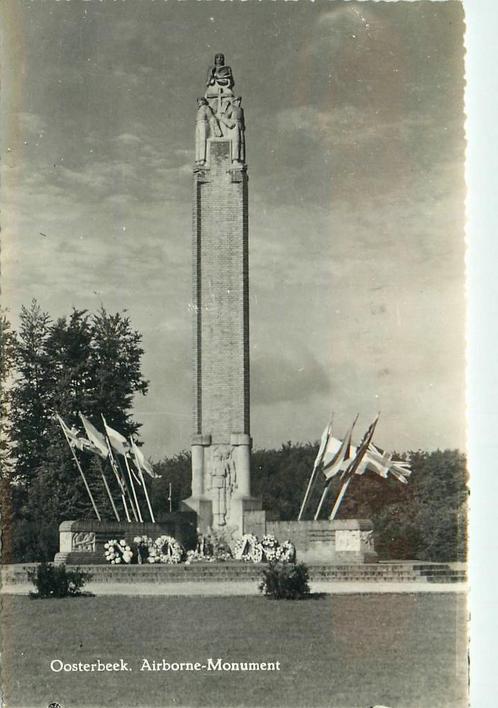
[2,0,465,458]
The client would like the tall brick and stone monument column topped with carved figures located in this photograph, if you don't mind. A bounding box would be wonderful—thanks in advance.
[184,54,261,533]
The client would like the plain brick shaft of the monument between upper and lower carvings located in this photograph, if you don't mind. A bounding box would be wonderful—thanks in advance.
[193,140,249,444]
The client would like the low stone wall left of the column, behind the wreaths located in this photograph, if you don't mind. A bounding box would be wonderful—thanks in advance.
[54,511,197,565]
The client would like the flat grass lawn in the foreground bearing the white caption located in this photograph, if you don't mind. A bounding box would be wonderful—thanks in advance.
[2,593,467,708]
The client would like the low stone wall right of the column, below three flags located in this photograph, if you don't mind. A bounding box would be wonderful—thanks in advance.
[244,511,377,564]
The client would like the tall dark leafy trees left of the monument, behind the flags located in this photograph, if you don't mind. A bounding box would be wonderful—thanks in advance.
[0,301,148,560]
